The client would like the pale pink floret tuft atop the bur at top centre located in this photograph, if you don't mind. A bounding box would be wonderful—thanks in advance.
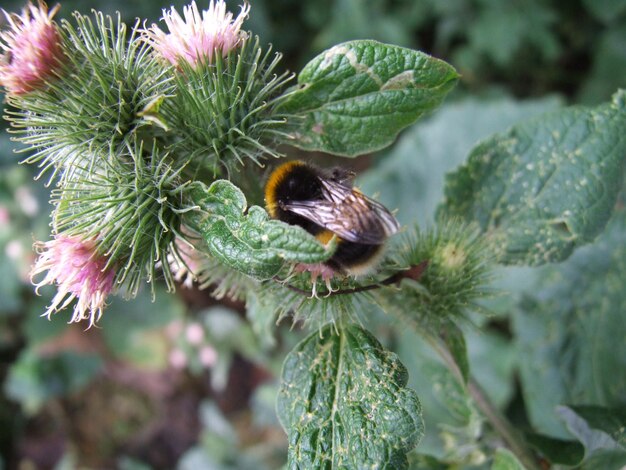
[144,0,250,68]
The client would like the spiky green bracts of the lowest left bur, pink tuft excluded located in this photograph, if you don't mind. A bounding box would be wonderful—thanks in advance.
[53,142,193,302]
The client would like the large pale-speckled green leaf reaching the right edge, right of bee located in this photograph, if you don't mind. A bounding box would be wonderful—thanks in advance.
[441,91,626,266]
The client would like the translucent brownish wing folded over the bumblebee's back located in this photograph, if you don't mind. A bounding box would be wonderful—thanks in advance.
[285,179,399,245]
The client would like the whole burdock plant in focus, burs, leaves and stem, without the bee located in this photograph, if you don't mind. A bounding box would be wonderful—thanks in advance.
[0,0,626,469]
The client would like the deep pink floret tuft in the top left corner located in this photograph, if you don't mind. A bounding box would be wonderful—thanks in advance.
[0,2,63,95]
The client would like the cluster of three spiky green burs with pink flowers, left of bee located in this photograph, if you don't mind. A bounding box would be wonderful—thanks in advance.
[2,0,291,324]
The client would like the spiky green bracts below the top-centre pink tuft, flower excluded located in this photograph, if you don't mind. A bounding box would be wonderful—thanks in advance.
[160,37,291,176]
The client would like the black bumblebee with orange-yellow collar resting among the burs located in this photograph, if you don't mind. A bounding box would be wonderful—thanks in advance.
[265,160,399,276]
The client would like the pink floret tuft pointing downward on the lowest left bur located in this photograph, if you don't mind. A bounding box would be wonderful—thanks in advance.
[31,235,115,327]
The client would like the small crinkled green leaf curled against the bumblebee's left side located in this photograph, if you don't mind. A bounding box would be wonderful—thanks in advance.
[187,180,335,279]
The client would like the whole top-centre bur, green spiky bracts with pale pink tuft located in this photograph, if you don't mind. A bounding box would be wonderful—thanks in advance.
[142,0,291,174]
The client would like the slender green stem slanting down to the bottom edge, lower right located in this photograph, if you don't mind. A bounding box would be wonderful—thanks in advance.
[431,337,540,470]
